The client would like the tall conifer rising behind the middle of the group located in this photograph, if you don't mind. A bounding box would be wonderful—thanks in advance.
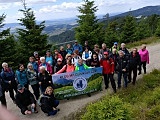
[75,0,104,45]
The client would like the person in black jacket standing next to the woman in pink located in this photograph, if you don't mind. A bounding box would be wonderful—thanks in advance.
[128,48,141,85]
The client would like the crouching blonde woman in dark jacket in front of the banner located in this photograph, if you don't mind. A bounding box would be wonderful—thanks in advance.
[40,86,59,116]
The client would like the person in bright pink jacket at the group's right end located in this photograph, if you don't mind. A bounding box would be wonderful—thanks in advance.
[138,44,149,75]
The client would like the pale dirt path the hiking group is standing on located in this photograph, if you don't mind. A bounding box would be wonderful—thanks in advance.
[6,44,160,120]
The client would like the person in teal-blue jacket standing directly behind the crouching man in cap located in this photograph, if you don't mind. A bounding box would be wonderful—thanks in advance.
[16,64,28,89]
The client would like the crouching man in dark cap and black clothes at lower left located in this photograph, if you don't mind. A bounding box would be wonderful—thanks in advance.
[16,84,38,115]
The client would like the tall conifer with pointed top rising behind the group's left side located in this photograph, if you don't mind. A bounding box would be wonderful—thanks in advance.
[17,0,47,63]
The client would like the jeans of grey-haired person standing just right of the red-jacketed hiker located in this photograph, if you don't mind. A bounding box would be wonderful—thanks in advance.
[118,72,128,88]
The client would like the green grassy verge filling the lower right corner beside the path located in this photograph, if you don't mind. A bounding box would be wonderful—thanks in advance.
[75,70,160,120]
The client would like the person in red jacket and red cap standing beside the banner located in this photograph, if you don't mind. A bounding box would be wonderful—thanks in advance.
[100,52,116,92]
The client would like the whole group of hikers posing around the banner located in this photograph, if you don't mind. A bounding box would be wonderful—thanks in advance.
[0,41,149,115]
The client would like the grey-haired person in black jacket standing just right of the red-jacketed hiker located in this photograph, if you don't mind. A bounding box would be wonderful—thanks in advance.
[116,50,129,88]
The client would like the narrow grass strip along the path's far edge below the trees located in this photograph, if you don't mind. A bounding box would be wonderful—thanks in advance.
[126,37,160,48]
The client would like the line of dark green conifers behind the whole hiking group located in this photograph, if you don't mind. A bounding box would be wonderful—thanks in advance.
[0,0,160,69]
